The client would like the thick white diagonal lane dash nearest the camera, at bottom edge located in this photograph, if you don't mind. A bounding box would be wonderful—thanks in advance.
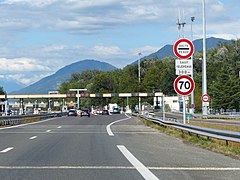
[117,145,158,180]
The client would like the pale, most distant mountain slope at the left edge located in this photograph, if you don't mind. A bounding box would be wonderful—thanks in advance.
[0,77,26,93]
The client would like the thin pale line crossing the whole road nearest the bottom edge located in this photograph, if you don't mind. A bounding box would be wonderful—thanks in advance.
[0,166,240,171]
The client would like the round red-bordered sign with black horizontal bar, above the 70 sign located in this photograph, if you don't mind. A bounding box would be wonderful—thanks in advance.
[173,38,194,59]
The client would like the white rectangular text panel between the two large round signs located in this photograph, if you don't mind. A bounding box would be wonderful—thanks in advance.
[175,59,192,75]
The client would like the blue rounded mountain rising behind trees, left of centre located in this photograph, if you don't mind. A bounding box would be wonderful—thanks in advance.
[12,60,117,94]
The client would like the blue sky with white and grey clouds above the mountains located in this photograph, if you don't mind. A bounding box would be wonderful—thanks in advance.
[0,0,240,85]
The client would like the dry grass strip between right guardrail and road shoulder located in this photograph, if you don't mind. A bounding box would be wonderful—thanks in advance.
[141,118,240,159]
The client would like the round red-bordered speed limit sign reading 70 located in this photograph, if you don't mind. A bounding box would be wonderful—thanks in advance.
[173,75,195,96]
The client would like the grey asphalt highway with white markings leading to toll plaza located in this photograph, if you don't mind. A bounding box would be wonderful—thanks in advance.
[0,115,240,180]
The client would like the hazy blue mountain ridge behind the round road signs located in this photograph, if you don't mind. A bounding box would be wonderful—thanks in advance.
[141,37,231,61]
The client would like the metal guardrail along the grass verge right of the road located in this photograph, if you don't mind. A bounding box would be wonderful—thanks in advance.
[132,114,240,145]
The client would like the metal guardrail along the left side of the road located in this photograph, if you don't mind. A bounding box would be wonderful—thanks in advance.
[0,113,66,126]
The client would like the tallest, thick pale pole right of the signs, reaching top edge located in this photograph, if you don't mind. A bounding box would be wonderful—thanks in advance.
[202,0,207,117]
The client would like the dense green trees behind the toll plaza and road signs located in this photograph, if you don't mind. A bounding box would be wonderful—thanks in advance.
[60,40,240,111]
